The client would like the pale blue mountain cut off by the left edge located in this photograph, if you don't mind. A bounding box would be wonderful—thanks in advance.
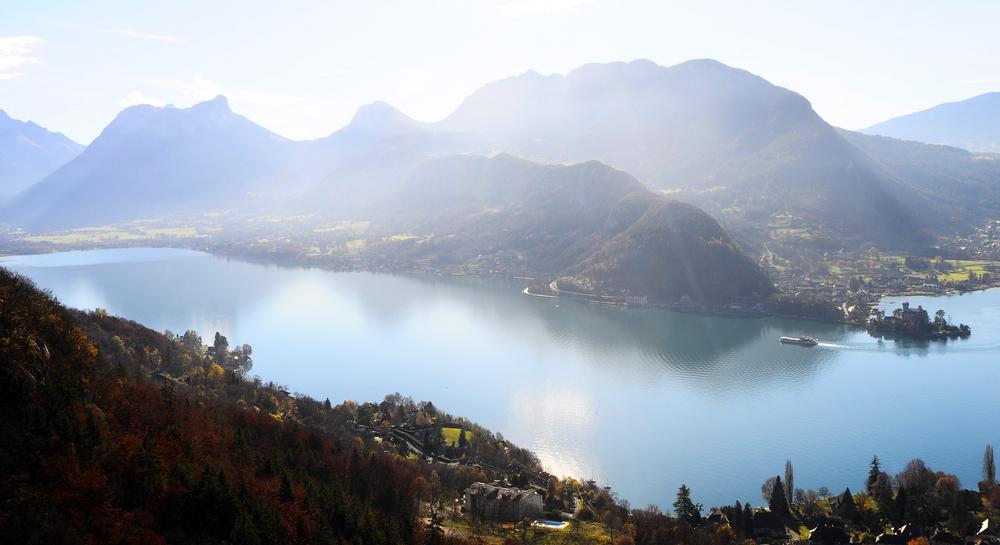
[0,110,83,202]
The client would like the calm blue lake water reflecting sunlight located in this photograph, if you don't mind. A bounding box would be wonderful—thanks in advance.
[0,249,1000,509]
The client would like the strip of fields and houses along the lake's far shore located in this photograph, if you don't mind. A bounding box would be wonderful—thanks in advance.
[0,214,1000,338]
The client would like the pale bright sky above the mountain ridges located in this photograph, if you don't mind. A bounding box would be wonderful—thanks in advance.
[0,0,1000,144]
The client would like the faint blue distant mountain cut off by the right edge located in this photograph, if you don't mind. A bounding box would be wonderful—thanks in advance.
[861,93,1000,153]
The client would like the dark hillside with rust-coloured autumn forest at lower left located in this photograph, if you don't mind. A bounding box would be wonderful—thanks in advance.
[0,269,552,545]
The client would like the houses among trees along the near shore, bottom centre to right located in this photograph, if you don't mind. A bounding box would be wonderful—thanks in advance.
[351,394,1000,545]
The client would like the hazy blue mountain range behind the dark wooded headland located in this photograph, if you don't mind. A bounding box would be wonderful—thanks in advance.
[2,60,1000,298]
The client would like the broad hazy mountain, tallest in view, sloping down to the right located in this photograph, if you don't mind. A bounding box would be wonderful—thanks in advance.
[440,60,1000,246]
